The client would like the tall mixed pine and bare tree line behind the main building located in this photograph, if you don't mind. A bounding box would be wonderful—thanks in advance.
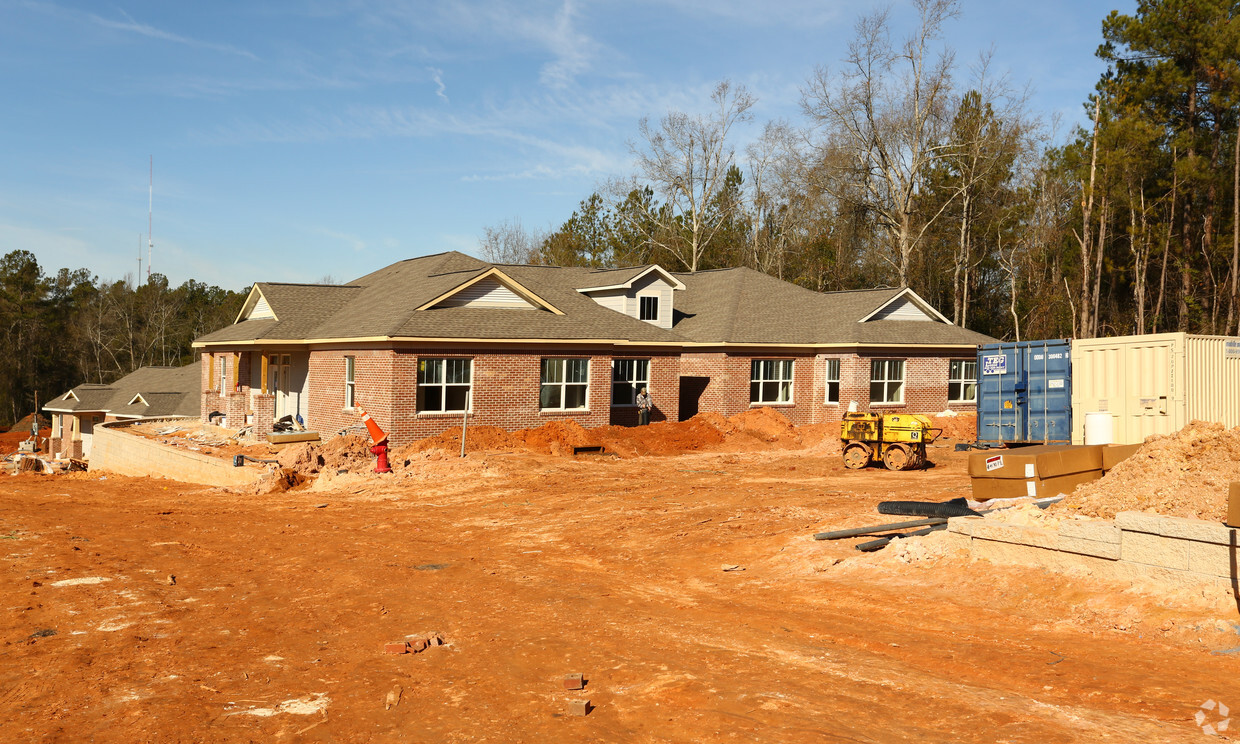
[480,0,1240,340]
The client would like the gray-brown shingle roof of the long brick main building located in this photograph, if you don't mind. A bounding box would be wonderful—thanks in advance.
[197,252,993,346]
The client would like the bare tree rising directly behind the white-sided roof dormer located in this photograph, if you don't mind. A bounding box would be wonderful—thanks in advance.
[613,81,756,272]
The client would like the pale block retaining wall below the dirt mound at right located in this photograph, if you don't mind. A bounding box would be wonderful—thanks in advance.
[947,512,1240,588]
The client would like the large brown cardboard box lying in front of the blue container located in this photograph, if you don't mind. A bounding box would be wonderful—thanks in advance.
[968,444,1105,501]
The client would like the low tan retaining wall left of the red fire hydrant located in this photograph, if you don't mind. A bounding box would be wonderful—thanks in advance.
[89,418,267,487]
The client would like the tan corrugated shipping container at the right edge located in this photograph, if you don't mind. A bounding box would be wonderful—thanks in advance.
[1073,334,1240,444]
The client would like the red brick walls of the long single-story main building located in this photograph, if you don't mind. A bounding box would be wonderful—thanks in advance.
[202,346,975,446]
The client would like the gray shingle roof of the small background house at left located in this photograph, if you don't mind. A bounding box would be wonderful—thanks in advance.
[43,362,202,418]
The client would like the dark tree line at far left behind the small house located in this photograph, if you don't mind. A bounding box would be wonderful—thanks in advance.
[0,250,246,425]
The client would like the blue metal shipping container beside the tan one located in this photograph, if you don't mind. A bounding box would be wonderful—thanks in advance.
[977,339,1073,445]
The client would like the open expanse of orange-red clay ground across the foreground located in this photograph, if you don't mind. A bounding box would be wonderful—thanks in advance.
[0,416,1240,744]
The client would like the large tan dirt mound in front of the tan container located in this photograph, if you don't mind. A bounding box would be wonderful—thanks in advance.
[1060,422,1240,522]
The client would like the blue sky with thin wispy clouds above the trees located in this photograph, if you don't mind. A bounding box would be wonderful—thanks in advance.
[0,0,1135,289]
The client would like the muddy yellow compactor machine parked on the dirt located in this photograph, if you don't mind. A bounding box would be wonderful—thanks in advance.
[839,412,942,470]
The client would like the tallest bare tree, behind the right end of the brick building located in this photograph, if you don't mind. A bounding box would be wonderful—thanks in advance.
[802,0,959,286]
